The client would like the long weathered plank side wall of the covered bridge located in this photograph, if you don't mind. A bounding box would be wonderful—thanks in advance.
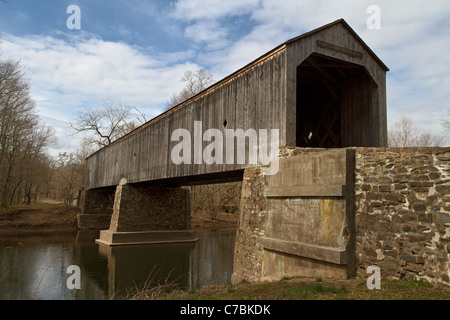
[86,47,286,189]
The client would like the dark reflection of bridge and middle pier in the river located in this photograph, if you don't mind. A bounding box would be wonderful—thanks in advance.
[94,232,235,299]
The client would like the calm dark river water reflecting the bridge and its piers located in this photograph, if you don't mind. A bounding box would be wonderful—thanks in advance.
[0,231,235,300]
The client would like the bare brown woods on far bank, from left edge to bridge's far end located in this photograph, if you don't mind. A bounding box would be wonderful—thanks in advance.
[0,55,86,208]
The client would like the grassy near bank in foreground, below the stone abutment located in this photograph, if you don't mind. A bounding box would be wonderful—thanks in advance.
[132,277,450,300]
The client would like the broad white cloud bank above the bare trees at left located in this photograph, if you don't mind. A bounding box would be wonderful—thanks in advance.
[2,35,198,120]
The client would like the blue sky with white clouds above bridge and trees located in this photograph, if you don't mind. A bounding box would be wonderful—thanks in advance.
[0,0,450,155]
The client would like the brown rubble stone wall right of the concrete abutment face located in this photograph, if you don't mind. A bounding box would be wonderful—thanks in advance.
[355,148,450,285]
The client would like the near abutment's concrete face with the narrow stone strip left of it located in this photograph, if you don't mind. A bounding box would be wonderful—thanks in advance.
[232,149,356,283]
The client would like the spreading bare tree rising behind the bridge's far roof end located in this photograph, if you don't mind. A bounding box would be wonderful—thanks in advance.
[70,102,146,149]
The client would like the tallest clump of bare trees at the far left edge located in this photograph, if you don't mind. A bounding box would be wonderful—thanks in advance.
[0,60,54,207]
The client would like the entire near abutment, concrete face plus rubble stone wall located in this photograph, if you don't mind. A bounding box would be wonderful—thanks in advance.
[232,148,450,286]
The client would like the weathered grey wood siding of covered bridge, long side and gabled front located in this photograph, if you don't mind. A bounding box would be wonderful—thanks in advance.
[86,20,388,189]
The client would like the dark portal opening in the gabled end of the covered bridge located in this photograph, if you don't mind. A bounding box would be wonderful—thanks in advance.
[296,53,379,148]
